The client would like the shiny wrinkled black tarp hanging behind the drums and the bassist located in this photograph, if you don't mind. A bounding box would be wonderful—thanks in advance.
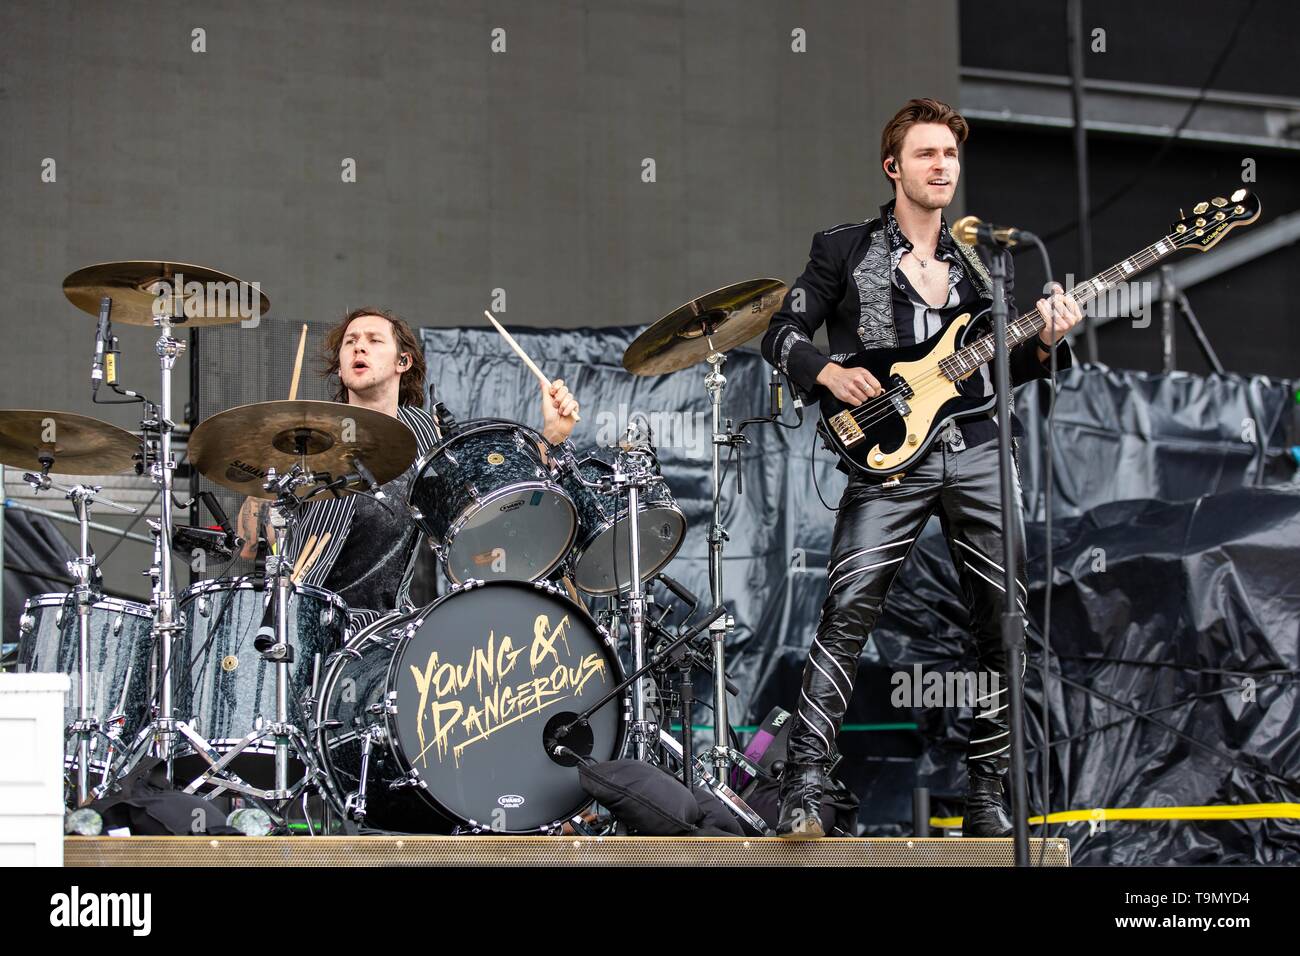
[423,328,1300,862]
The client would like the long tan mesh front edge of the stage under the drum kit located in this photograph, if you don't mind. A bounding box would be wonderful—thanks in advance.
[64,836,1070,866]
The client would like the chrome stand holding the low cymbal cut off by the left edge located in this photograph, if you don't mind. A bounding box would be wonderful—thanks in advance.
[22,453,135,806]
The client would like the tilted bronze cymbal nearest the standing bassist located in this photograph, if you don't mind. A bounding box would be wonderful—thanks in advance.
[623,278,787,375]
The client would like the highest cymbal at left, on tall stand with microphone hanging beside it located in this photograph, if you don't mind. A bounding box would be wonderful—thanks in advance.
[64,260,270,328]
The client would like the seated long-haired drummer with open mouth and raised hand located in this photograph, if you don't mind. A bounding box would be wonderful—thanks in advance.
[238,308,577,627]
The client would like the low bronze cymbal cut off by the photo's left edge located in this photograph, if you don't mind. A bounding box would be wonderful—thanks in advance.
[0,408,140,475]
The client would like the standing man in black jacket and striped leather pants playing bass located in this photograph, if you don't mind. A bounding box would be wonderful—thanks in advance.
[763,99,1082,839]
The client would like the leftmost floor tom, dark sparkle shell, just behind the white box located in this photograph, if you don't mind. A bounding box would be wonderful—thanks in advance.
[18,594,153,771]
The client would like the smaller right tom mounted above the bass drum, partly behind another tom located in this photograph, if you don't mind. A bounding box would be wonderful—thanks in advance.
[560,455,686,594]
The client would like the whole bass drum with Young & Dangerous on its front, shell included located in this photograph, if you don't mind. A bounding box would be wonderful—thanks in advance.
[316,581,627,834]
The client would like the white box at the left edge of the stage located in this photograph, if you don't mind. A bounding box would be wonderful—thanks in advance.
[0,674,72,866]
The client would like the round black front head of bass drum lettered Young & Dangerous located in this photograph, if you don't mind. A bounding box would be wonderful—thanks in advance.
[387,581,627,834]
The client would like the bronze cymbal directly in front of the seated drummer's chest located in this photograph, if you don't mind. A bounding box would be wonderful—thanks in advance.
[190,399,417,498]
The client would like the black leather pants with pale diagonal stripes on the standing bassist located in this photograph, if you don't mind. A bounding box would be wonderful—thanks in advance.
[789,433,1028,777]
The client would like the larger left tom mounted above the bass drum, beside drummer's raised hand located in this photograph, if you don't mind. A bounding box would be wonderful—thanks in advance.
[408,419,577,584]
